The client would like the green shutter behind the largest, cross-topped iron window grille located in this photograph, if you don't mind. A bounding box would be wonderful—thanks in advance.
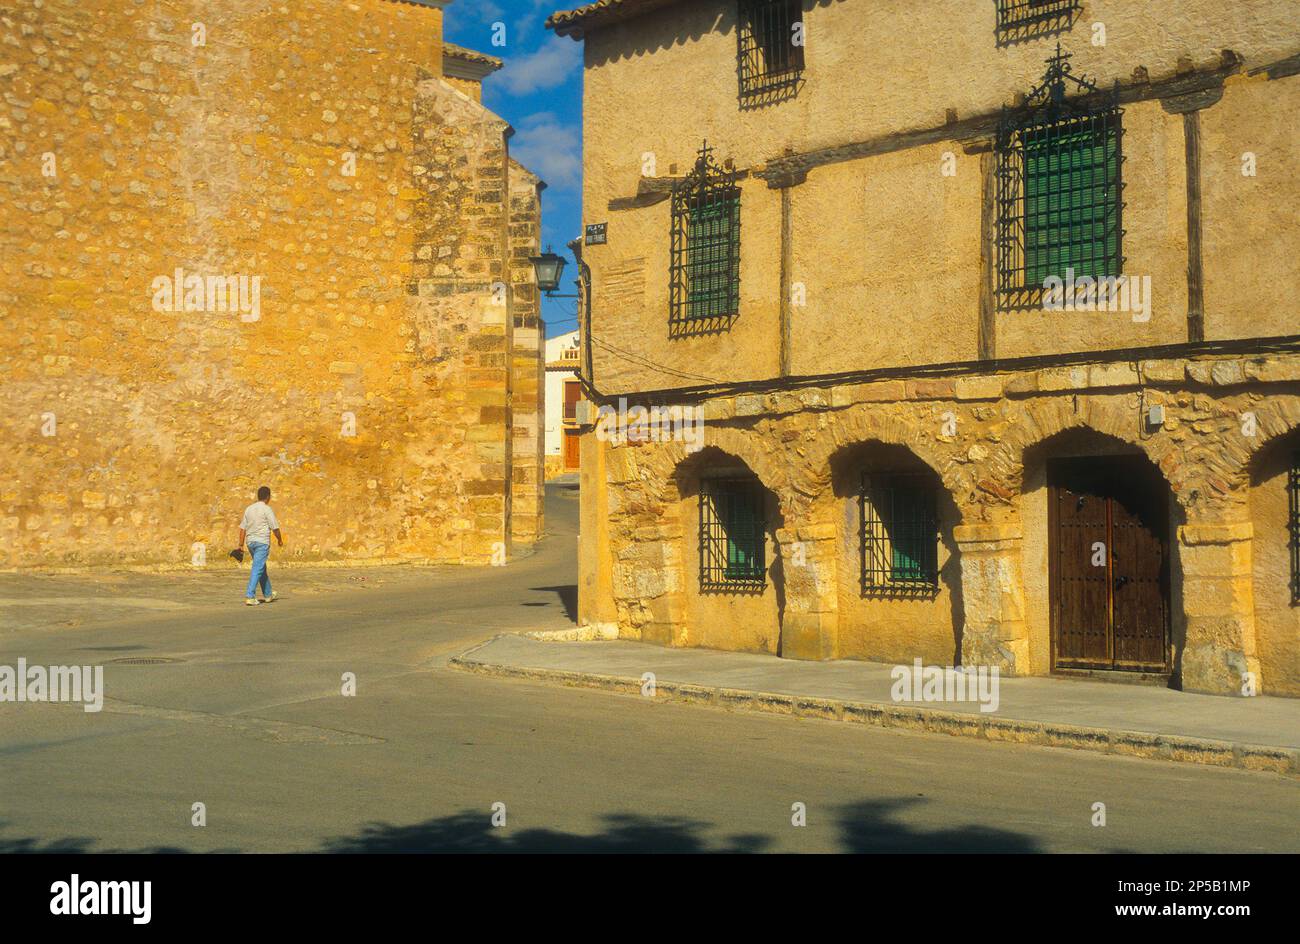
[1023,120,1119,286]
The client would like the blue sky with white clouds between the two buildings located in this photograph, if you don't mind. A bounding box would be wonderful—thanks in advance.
[443,0,582,337]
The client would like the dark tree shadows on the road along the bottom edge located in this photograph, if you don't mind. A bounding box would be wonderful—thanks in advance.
[0,797,1043,854]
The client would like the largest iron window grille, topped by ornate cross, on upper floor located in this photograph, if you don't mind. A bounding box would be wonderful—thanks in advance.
[996,47,1125,308]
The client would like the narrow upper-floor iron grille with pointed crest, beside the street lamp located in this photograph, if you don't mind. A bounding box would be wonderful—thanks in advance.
[668,143,740,337]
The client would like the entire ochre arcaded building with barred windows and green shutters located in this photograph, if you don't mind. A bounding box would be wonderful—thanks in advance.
[549,0,1300,696]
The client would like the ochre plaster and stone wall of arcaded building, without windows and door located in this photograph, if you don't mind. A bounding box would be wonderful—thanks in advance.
[553,0,1300,694]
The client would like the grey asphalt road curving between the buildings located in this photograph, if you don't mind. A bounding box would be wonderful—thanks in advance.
[0,488,1300,852]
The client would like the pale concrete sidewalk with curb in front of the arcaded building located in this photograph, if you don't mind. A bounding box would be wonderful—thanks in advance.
[451,635,1300,776]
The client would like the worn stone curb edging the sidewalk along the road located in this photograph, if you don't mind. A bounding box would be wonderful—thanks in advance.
[447,655,1300,778]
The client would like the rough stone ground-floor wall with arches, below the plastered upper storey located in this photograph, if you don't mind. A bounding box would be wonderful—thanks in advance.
[580,354,1300,696]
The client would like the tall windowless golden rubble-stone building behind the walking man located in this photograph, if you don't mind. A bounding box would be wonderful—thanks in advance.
[0,0,545,568]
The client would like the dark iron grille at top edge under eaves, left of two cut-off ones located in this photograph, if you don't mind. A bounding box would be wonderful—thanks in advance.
[736,0,803,105]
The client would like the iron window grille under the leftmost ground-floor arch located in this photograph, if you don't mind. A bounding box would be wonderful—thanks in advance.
[699,479,767,592]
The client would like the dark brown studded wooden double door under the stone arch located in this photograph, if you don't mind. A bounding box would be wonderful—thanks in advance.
[1048,456,1169,671]
